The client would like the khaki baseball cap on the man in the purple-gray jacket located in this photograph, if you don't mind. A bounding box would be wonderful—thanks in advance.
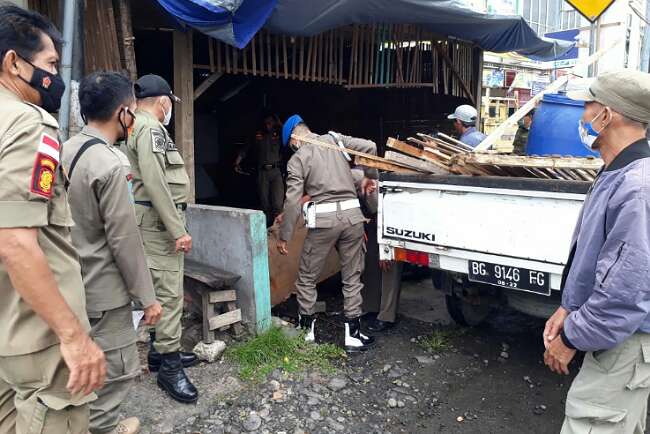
[566,69,650,123]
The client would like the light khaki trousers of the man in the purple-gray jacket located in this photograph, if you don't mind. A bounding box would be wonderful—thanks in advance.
[562,333,650,434]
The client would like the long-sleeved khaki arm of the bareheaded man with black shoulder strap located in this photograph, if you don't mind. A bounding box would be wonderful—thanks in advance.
[94,165,156,308]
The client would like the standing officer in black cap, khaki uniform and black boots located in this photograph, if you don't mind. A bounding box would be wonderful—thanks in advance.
[124,75,198,403]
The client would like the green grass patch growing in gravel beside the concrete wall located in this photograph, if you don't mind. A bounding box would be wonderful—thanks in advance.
[226,327,346,381]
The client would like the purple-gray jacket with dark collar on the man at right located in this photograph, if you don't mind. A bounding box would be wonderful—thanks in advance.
[562,140,650,351]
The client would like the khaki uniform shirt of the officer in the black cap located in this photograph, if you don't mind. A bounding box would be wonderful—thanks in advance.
[123,110,190,240]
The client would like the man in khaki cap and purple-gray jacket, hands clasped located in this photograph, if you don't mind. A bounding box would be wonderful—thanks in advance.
[543,70,650,434]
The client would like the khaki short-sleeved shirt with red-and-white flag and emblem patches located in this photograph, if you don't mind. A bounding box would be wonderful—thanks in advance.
[0,86,90,356]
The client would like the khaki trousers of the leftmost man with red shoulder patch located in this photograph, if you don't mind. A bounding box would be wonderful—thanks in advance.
[0,345,95,434]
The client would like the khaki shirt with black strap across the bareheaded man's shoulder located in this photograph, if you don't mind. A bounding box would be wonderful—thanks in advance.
[62,126,156,318]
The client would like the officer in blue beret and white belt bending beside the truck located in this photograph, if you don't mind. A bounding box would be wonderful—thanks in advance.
[278,115,377,351]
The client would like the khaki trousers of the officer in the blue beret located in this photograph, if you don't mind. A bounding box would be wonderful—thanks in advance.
[296,221,363,318]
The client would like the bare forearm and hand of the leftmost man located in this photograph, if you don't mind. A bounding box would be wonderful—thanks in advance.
[0,228,106,395]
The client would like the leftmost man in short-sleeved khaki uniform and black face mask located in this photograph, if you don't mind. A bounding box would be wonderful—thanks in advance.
[0,5,105,434]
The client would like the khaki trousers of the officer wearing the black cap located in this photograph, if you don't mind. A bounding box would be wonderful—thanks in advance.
[136,207,185,354]
